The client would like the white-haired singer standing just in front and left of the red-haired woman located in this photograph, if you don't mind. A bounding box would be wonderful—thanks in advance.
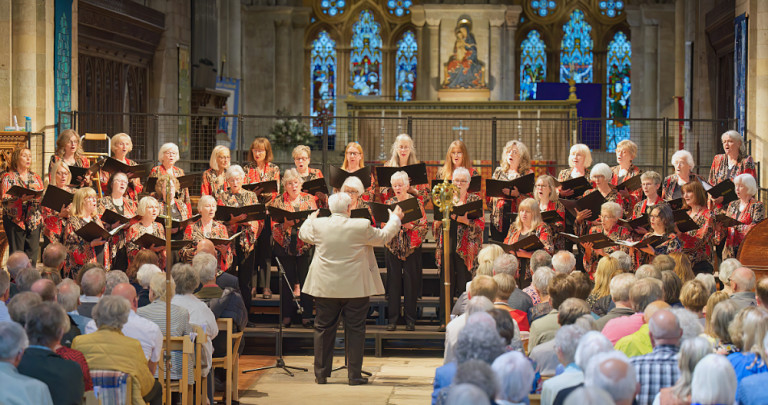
[219,165,266,309]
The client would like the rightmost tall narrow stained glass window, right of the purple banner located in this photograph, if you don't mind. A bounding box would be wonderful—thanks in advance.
[605,31,632,152]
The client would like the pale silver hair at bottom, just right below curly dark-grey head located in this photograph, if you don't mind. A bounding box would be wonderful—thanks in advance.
[491,352,535,402]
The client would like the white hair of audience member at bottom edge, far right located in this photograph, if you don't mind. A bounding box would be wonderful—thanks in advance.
[691,353,737,404]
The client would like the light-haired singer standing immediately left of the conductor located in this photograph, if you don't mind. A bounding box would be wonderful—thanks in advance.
[269,167,318,328]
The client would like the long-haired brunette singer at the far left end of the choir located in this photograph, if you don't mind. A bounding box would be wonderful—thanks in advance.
[0,148,44,265]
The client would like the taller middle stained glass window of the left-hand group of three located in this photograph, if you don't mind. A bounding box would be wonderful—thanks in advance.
[349,10,381,96]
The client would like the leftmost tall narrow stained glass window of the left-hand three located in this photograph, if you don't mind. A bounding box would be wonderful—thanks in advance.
[310,31,336,135]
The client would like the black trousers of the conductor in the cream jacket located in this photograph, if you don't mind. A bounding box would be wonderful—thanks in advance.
[315,297,370,378]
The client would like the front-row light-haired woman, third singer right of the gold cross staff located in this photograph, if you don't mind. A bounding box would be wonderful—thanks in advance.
[581,201,632,276]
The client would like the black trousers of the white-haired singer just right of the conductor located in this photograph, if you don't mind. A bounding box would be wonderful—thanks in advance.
[384,247,421,324]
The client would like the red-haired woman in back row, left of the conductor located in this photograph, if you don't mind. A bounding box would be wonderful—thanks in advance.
[245,137,280,298]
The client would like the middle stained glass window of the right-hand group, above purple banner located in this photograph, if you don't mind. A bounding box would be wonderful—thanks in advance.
[560,9,593,83]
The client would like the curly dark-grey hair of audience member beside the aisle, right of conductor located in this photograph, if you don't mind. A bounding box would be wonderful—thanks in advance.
[454,315,506,364]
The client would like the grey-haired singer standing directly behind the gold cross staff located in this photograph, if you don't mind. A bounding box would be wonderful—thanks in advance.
[432,167,485,328]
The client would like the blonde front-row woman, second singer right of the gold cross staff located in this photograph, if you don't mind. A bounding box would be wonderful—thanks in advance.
[504,198,555,289]
